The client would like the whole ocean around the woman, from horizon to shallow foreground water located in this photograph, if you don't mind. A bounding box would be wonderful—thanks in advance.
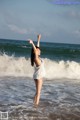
[0,39,80,120]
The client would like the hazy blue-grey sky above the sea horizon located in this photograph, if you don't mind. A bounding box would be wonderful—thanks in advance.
[0,0,80,44]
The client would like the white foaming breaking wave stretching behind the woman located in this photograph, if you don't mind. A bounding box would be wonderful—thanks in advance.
[0,54,80,79]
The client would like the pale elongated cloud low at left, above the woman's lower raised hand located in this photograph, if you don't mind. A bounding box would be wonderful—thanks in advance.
[8,24,28,34]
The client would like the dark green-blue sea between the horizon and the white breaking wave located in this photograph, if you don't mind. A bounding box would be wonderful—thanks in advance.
[0,41,80,61]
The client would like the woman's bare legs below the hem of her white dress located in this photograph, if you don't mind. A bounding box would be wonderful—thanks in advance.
[36,79,43,105]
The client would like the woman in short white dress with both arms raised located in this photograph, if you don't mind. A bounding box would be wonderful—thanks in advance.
[29,35,45,105]
